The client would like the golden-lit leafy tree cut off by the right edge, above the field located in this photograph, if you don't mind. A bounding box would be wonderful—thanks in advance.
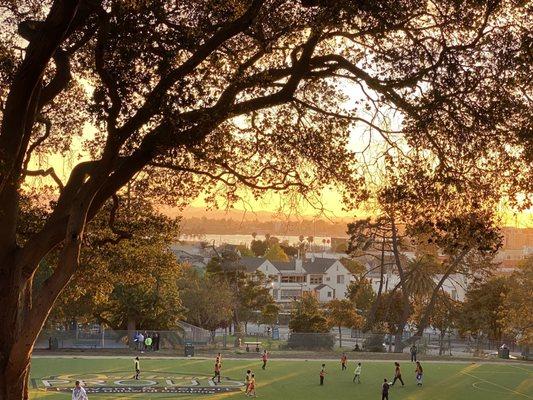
[500,256,533,345]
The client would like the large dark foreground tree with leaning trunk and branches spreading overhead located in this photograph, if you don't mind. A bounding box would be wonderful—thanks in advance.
[0,0,533,399]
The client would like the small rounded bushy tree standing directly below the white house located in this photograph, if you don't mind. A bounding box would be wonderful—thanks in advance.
[289,294,331,333]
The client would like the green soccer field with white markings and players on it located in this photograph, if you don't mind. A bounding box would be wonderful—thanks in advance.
[30,357,533,400]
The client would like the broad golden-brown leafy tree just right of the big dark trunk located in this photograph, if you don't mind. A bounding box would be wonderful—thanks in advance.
[44,199,181,329]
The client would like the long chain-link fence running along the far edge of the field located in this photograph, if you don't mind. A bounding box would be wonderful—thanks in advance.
[35,322,531,358]
